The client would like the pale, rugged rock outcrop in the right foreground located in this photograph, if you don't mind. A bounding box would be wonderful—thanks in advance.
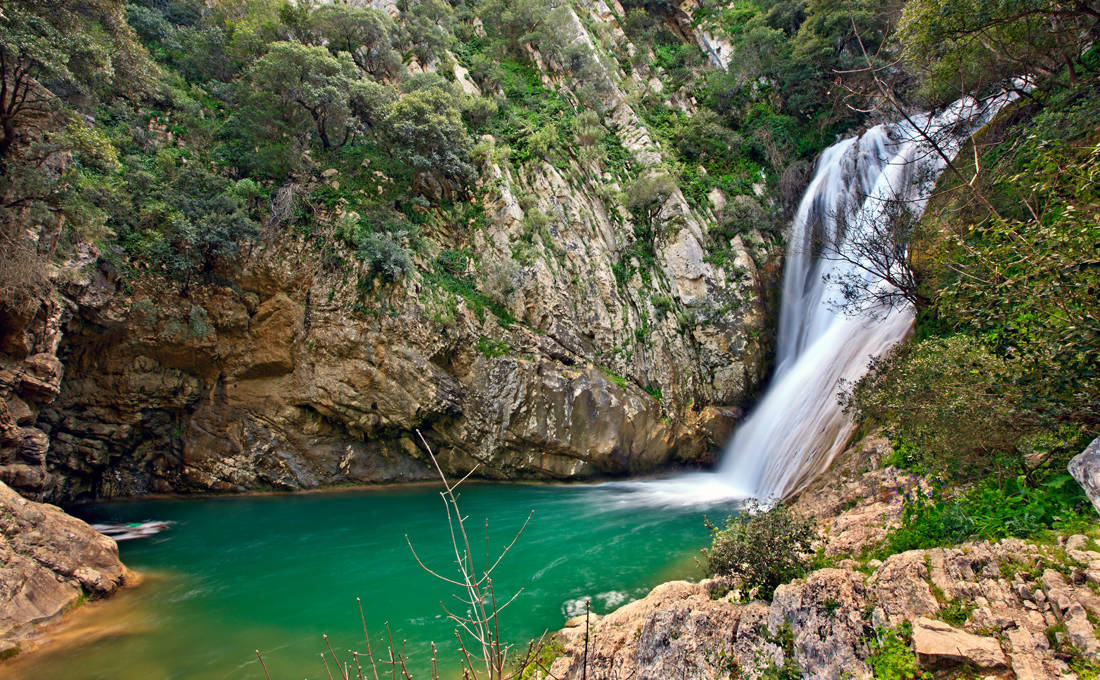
[549,536,1100,680]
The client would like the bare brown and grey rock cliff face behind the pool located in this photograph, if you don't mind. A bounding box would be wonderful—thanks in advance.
[0,2,777,500]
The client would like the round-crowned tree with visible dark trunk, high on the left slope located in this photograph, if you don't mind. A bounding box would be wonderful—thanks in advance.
[250,41,360,150]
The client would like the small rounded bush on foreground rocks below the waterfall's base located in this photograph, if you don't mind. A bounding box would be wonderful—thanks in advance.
[703,502,816,599]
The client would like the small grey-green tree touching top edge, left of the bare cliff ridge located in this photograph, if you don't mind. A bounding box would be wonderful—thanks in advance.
[309,4,402,76]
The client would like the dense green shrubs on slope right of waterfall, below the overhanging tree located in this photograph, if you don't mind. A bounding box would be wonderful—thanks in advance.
[847,80,1100,512]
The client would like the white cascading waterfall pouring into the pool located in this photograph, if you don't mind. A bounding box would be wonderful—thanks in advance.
[611,95,1013,503]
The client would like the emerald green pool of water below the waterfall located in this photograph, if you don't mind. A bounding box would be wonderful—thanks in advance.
[8,484,722,680]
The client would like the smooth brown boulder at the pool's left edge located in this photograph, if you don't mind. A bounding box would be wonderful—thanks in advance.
[0,482,133,657]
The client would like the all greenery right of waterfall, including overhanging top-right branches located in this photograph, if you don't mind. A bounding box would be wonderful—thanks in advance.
[848,2,1100,550]
